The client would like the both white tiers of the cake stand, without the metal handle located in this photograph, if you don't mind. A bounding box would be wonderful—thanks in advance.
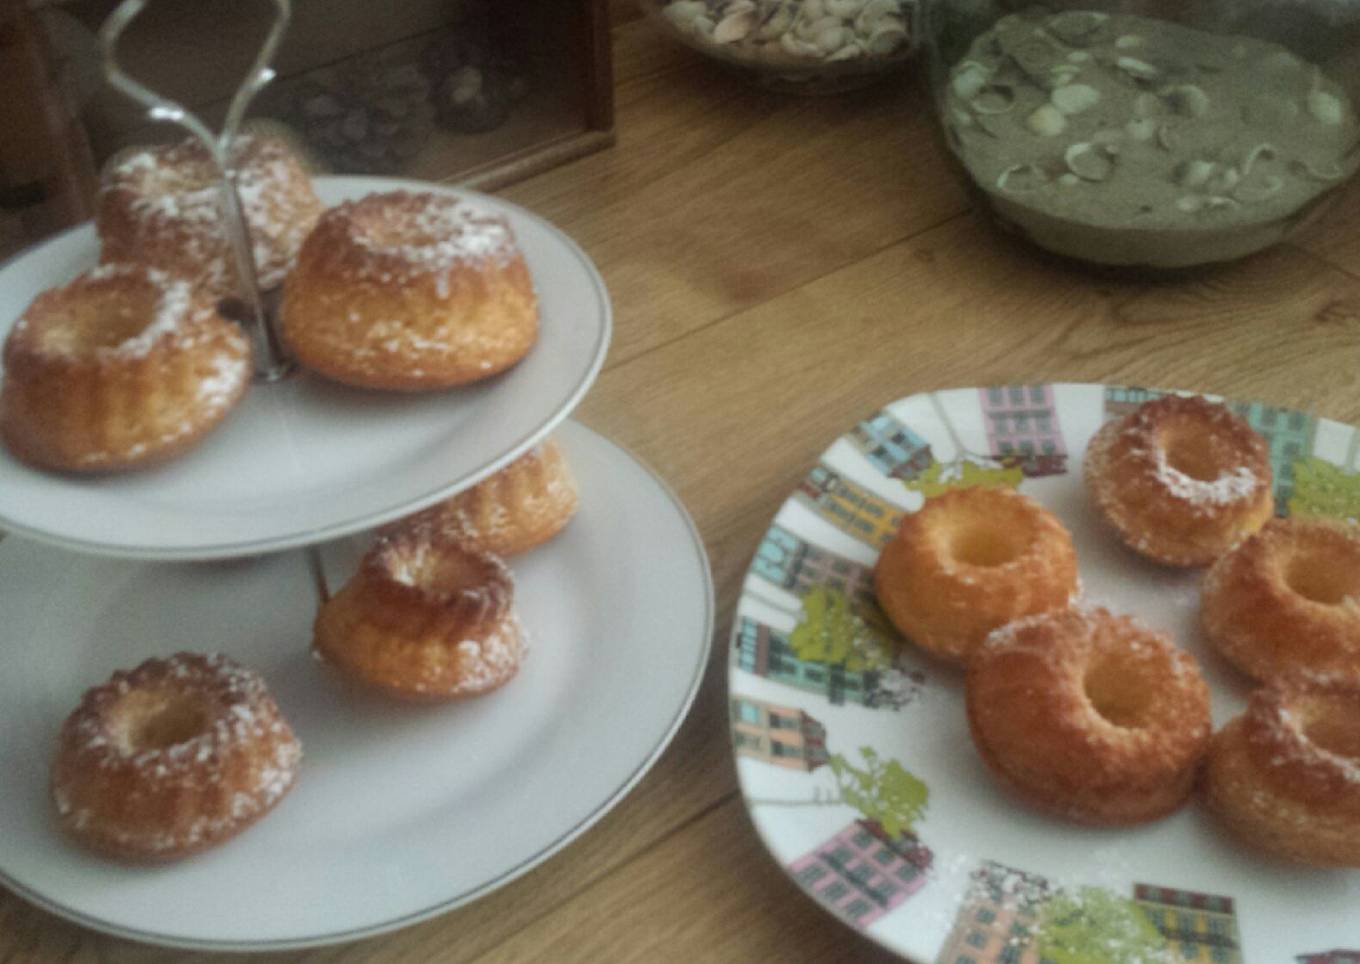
[0,9,713,950]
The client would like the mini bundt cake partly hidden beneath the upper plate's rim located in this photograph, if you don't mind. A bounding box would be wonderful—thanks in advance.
[398,439,577,556]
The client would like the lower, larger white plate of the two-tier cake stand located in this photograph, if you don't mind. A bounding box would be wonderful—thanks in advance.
[0,423,713,950]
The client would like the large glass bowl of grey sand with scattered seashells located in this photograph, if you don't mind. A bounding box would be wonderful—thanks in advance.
[919,0,1360,269]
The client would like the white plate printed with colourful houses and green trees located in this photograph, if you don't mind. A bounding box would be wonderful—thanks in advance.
[728,385,1360,964]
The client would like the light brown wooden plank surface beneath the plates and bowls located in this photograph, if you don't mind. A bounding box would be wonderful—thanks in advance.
[0,13,1360,964]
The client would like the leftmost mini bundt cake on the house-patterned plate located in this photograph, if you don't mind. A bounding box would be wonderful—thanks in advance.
[873,487,1077,664]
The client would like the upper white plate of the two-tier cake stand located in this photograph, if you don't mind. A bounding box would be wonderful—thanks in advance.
[0,177,611,559]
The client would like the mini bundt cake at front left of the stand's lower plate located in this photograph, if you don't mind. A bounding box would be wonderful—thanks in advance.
[52,653,302,861]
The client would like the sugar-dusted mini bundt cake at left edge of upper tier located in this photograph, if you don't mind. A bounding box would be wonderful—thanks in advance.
[0,265,252,472]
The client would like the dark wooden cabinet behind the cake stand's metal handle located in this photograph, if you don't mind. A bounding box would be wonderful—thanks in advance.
[0,0,613,255]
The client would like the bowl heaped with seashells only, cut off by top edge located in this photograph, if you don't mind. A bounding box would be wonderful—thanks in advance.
[639,0,915,94]
